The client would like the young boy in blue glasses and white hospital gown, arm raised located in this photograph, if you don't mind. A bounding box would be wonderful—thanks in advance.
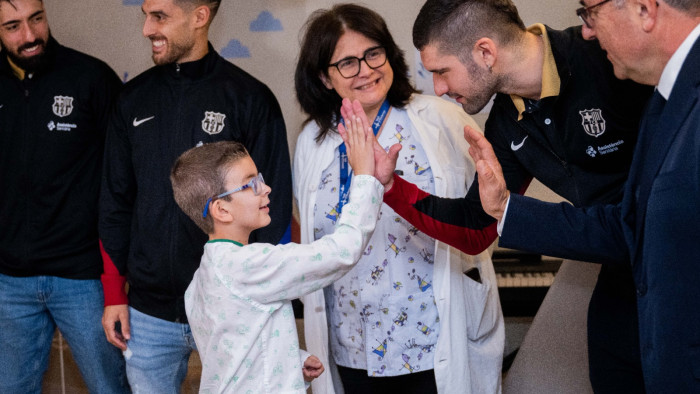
[170,111,384,393]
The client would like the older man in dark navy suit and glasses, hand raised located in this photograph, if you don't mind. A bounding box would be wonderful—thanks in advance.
[465,0,700,393]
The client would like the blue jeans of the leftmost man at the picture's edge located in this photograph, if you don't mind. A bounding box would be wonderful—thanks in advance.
[0,274,129,394]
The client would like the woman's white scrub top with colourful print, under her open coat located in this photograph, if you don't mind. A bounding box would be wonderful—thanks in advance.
[314,108,439,376]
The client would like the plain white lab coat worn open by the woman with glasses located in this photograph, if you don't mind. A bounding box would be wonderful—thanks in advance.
[293,95,505,394]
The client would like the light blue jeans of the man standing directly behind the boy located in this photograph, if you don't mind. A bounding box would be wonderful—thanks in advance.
[124,307,197,394]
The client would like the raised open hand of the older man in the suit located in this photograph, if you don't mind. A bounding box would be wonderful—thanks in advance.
[464,126,510,221]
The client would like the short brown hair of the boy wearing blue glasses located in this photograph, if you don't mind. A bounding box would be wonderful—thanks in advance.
[170,141,249,234]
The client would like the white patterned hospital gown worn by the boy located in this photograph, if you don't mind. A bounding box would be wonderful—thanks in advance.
[185,175,384,394]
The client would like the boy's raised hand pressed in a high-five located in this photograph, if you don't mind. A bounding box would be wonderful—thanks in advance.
[338,99,376,175]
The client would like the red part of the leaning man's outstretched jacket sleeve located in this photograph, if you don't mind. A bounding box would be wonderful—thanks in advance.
[384,175,498,255]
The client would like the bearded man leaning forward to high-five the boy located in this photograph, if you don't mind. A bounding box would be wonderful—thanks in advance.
[360,0,652,392]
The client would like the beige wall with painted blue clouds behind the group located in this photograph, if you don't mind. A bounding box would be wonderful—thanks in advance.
[44,0,579,203]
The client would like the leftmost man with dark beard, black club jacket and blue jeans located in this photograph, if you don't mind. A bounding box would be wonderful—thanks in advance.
[0,0,129,393]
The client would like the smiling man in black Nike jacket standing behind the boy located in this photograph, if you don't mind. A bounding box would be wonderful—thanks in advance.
[99,0,292,393]
